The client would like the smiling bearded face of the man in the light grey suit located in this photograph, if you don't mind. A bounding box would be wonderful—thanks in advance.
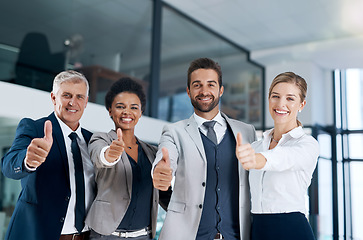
[187,69,223,119]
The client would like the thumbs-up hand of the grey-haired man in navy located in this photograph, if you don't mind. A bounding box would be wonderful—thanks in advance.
[25,120,53,168]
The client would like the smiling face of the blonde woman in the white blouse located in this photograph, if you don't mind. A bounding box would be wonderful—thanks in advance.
[269,82,306,129]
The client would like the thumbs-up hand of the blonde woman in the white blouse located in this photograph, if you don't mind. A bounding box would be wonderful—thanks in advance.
[236,133,257,170]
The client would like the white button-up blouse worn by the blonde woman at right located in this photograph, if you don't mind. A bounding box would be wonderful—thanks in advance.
[249,127,319,214]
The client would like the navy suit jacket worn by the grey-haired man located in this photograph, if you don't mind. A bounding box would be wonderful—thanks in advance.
[2,113,92,240]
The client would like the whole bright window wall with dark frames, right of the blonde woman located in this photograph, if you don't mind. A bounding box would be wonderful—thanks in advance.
[318,69,363,240]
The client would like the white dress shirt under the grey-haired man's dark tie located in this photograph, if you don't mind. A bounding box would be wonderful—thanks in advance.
[55,115,95,234]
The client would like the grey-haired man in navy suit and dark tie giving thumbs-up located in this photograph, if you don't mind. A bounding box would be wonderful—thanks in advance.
[2,70,95,240]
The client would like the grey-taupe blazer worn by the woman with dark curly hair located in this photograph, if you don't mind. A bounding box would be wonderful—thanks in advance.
[86,130,170,237]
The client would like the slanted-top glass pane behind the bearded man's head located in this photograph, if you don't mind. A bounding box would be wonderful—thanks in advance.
[158,8,263,129]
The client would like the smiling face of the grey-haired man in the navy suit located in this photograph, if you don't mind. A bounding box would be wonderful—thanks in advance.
[51,80,88,130]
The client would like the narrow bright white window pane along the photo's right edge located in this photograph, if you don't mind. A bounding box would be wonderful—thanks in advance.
[342,69,363,239]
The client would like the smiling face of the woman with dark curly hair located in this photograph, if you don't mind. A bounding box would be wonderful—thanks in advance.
[108,92,142,130]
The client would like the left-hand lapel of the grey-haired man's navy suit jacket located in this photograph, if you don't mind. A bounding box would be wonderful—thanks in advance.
[48,112,69,185]
